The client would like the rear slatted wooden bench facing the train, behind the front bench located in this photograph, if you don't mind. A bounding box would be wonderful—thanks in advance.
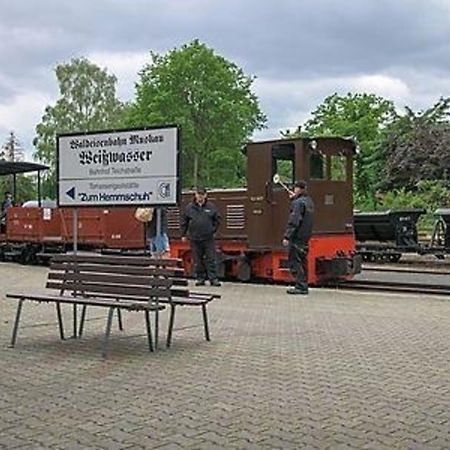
[51,254,220,347]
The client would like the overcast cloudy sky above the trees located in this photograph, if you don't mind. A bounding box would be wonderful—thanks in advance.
[0,0,450,158]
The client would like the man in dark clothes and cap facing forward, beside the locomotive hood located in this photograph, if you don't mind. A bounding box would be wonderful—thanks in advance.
[181,187,220,286]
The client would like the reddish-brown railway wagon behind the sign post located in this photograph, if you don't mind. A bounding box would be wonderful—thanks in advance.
[0,207,145,264]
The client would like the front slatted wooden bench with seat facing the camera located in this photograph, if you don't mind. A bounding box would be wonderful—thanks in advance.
[6,258,172,357]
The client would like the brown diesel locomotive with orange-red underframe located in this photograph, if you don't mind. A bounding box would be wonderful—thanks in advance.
[169,137,361,285]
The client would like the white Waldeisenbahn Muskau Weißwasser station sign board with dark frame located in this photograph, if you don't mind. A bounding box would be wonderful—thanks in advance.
[58,126,178,206]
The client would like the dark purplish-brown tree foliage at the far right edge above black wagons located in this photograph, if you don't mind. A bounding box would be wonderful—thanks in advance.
[382,98,450,189]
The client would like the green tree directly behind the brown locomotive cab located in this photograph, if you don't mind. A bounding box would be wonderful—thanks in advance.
[286,93,396,198]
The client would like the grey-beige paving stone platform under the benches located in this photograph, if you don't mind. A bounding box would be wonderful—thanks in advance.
[0,263,450,450]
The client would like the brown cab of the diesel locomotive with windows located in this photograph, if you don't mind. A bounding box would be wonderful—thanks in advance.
[247,138,354,248]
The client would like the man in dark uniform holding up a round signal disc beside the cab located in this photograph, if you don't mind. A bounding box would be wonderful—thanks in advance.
[283,180,314,295]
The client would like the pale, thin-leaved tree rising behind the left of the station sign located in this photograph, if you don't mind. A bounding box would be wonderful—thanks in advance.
[33,58,124,197]
